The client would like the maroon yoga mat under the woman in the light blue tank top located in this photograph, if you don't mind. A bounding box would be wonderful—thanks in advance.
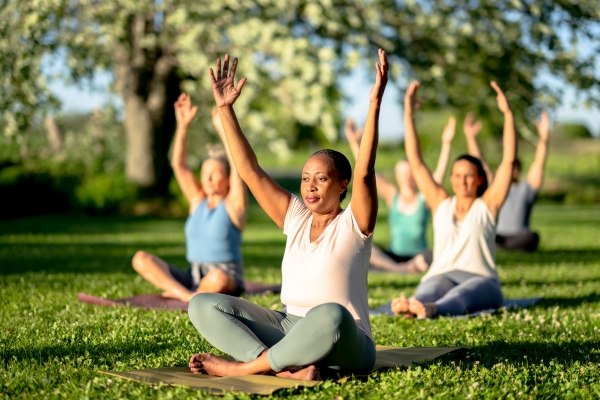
[77,282,281,311]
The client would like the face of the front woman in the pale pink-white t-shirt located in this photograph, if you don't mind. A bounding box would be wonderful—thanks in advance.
[300,154,348,214]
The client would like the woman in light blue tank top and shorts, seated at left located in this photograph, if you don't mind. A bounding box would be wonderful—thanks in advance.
[132,93,248,301]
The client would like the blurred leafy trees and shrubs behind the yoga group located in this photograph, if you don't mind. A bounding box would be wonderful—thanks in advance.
[0,0,600,217]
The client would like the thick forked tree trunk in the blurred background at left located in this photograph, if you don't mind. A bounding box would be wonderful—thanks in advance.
[114,15,180,195]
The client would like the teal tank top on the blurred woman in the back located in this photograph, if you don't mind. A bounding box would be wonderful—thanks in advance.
[388,193,429,256]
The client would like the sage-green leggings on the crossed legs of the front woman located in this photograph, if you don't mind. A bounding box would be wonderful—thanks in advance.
[188,293,375,374]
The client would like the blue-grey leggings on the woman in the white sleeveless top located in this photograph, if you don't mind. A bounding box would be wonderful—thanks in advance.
[413,271,503,315]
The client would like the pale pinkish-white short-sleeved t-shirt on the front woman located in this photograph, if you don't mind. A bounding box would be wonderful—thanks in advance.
[281,195,373,340]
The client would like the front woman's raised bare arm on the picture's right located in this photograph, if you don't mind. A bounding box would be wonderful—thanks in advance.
[350,49,388,235]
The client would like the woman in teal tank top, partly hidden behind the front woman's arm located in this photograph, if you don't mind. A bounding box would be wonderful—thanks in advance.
[345,117,456,273]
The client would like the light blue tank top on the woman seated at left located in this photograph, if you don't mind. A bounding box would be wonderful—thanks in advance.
[185,199,242,263]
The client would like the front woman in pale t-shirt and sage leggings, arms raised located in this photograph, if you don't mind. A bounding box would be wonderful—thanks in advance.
[188,50,388,379]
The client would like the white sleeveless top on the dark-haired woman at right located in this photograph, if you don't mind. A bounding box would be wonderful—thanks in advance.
[422,196,500,282]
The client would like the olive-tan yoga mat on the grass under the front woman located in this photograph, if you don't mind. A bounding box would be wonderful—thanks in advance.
[98,346,468,395]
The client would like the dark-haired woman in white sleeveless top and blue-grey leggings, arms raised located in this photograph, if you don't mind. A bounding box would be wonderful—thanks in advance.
[392,82,517,318]
